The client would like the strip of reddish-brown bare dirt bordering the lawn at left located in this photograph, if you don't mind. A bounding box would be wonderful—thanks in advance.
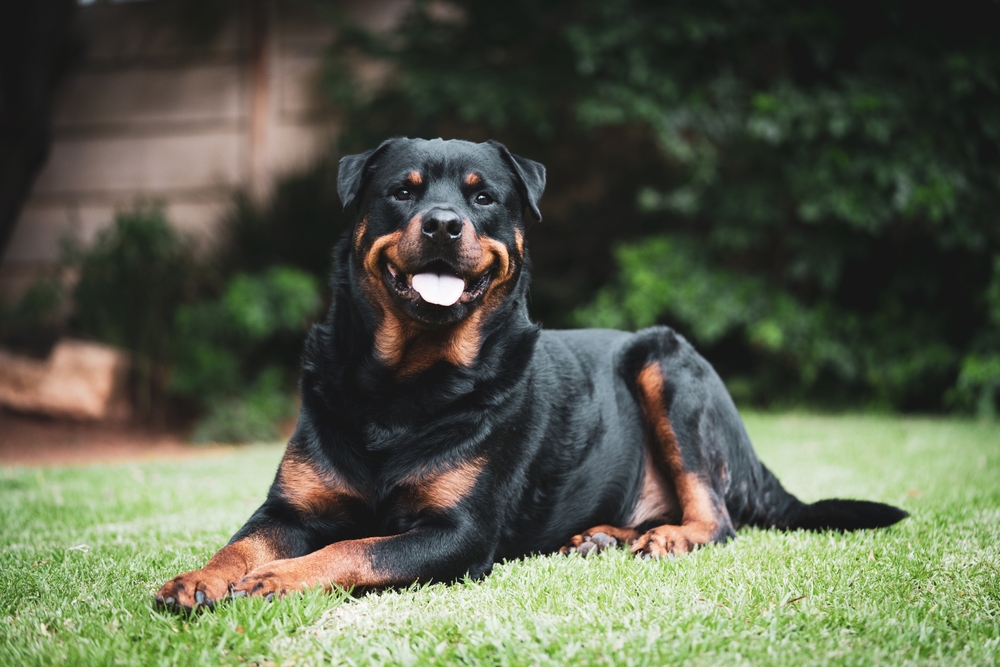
[0,410,235,466]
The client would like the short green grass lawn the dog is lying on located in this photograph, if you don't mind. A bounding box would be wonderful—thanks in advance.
[0,414,1000,665]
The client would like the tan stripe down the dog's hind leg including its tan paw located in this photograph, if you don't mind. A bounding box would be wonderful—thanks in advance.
[633,362,720,556]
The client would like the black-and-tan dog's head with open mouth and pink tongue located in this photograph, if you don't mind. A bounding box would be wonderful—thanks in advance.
[337,138,545,374]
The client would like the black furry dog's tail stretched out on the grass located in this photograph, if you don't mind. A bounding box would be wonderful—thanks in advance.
[755,467,909,531]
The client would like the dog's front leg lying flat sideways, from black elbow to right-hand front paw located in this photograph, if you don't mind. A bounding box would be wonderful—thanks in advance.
[233,526,491,596]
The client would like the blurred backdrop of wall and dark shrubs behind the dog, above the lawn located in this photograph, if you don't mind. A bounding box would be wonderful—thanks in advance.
[0,0,1000,442]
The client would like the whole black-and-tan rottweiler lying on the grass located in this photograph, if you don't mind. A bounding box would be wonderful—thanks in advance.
[155,138,906,610]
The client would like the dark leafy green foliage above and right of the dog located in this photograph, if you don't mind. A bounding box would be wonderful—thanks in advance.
[328,0,1000,414]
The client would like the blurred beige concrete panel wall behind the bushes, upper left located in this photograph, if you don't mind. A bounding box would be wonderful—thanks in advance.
[0,0,376,297]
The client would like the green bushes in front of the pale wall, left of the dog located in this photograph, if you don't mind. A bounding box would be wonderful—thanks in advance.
[60,207,321,442]
